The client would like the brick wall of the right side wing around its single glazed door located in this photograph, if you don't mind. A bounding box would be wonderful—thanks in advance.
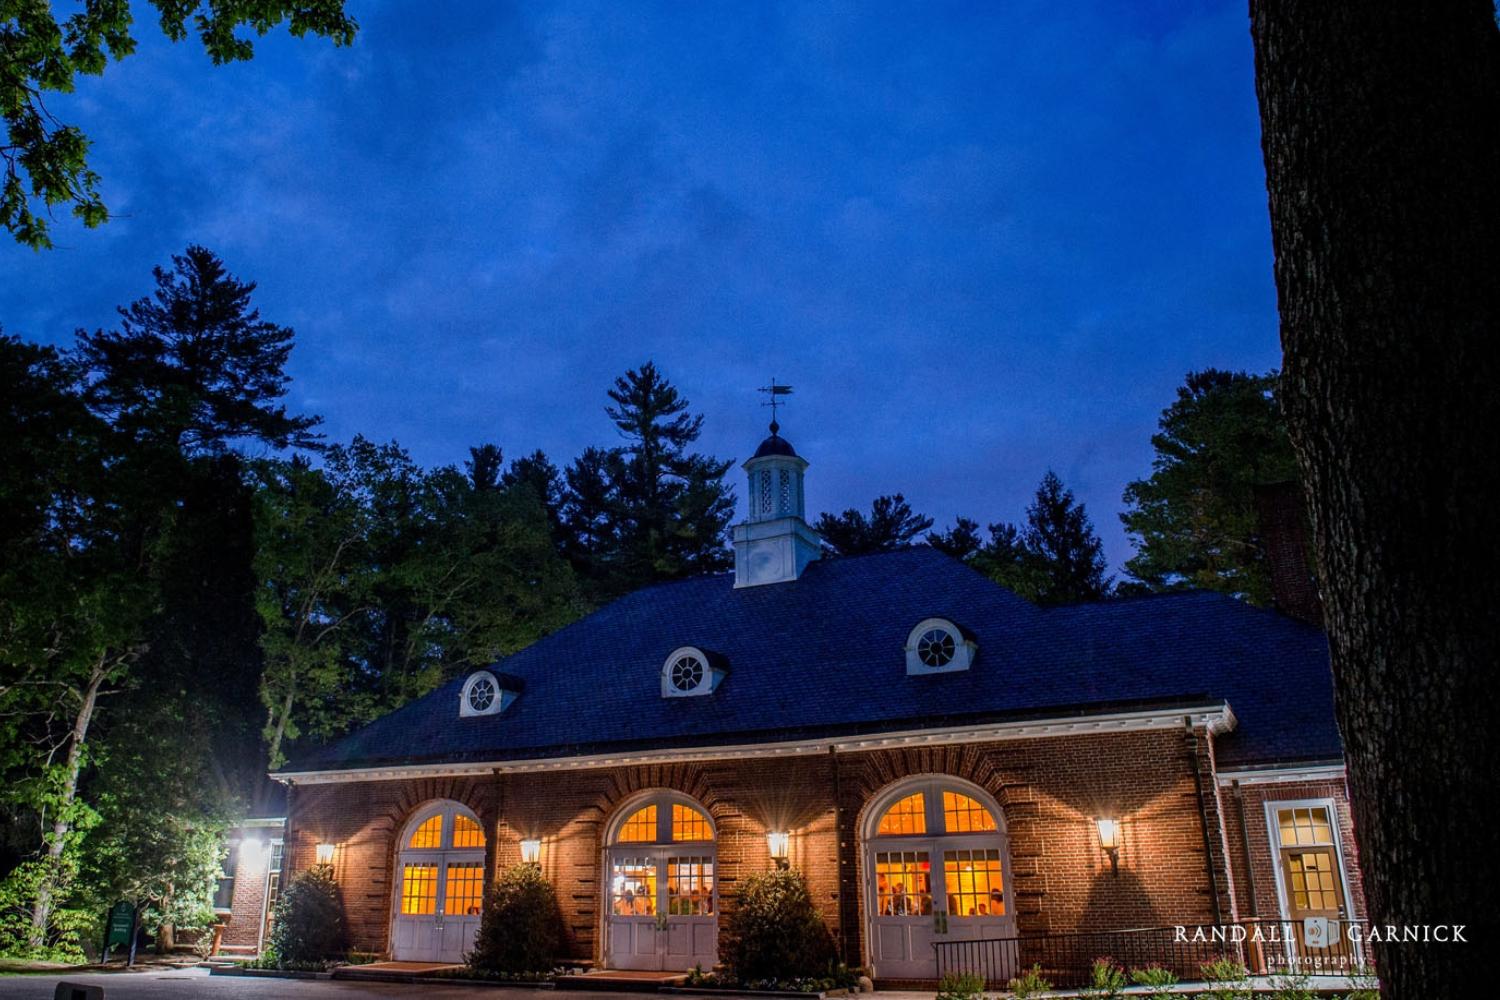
[1223,778,1368,919]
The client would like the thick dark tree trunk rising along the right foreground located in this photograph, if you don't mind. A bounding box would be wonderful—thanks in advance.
[1251,0,1500,999]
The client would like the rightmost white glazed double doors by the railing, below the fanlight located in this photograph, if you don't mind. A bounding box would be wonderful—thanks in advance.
[869,837,1016,979]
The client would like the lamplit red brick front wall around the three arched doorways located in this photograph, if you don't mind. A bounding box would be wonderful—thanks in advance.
[285,729,1260,963]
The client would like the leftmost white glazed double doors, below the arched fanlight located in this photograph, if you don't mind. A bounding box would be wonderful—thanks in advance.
[392,850,485,963]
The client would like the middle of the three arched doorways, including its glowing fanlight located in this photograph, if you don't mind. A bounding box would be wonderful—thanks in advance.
[605,792,719,970]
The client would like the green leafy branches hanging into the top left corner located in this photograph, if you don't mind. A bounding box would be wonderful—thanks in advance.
[0,0,356,249]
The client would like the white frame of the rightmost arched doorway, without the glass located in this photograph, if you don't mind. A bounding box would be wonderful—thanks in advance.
[860,774,1016,979]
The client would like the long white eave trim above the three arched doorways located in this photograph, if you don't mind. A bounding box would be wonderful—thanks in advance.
[272,702,1235,784]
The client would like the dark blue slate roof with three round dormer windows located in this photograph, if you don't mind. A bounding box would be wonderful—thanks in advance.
[285,546,1343,772]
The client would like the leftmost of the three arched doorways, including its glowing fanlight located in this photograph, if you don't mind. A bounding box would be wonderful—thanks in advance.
[390,801,485,963]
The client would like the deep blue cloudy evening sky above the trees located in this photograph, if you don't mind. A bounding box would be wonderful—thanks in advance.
[0,0,1280,570]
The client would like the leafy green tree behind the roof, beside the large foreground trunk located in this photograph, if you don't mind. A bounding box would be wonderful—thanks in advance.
[1121,369,1296,604]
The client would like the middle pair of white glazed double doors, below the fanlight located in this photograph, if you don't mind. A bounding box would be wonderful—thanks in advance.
[606,844,719,972]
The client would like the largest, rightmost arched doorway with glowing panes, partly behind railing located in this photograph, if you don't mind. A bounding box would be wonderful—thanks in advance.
[864,777,1016,979]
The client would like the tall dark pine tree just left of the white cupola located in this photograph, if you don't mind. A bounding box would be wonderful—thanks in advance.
[560,370,735,597]
